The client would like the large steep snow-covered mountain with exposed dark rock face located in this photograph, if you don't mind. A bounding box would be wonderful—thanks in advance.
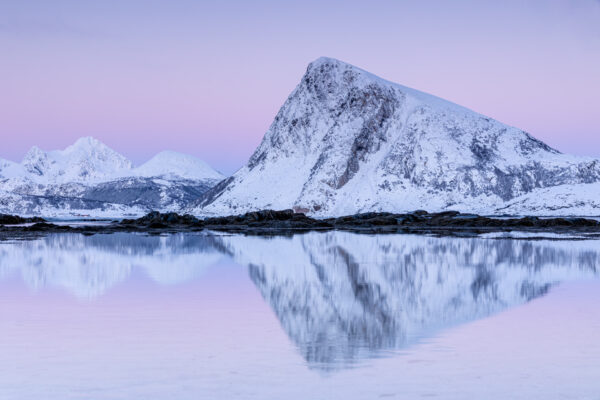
[189,58,600,216]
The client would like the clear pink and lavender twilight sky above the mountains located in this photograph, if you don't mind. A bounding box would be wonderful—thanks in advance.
[0,0,600,173]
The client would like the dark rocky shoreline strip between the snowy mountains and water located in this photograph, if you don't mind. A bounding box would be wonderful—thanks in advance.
[0,210,600,240]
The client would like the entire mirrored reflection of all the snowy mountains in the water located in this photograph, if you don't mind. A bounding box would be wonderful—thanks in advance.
[0,232,600,369]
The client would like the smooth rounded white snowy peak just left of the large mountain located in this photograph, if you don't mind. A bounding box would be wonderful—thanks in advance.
[135,151,224,180]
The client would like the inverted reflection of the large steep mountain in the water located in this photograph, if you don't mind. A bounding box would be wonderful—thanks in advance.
[218,232,600,369]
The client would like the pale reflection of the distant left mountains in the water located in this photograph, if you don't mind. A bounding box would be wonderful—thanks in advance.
[0,233,222,298]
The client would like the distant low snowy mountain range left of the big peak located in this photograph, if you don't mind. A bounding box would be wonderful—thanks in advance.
[0,137,224,217]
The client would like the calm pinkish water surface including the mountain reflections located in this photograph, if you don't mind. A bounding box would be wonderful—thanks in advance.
[0,232,600,400]
